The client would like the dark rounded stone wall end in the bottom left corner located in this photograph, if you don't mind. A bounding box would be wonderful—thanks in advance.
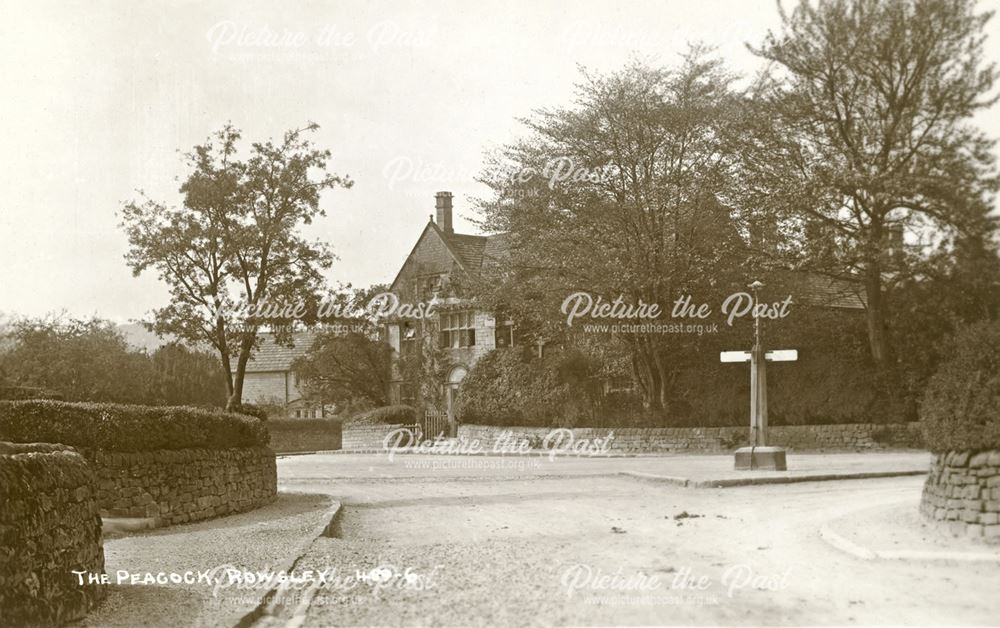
[0,443,106,626]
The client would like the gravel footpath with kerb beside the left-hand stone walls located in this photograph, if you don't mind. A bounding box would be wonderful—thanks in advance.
[76,493,334,627]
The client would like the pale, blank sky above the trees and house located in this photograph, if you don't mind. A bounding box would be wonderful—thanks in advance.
[0,0,1000,323]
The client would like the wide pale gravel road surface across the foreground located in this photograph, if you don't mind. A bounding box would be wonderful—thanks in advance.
[284,476,1000,626]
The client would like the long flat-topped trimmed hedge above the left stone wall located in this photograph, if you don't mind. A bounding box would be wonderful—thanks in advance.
[0,401,268,451]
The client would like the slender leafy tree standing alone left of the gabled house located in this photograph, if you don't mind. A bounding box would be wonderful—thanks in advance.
[122,124,351,409]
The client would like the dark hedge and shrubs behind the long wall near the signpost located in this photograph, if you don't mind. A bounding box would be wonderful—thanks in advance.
[460,307,915,427]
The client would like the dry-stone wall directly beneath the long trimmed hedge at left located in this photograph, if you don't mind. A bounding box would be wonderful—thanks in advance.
[87,447,278,524]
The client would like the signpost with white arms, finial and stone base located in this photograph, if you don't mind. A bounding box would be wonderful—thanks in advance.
[719,281,799,471]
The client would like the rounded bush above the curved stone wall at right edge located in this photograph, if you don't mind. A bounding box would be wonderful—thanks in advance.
[920,322,1000,452]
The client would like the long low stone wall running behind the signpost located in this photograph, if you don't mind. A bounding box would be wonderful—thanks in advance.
[458,423,923,453]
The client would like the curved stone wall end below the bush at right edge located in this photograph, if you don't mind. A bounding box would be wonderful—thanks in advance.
[920,450,1000,543]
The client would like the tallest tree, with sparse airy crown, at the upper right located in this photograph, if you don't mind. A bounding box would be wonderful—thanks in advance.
[742,0,997,374]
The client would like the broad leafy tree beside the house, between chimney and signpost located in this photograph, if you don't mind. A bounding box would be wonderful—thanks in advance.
[480,49,748,408]
